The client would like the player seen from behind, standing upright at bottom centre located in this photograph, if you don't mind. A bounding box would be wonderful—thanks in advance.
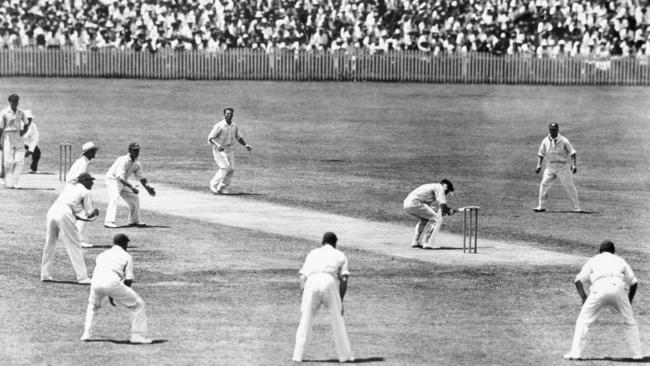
[292,232,354,362]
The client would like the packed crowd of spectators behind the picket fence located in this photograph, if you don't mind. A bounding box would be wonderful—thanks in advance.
[0,0,650,57]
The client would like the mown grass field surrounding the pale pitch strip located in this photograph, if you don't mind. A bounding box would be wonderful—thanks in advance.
[0,79,650,365]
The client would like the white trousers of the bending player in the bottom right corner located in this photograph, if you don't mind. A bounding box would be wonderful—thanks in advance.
[569,277,642,357]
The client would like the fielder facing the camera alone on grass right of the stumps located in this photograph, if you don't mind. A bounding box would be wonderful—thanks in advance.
[533,122,580,212]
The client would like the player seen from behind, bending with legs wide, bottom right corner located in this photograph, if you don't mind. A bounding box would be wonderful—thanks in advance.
[564,240,643,360]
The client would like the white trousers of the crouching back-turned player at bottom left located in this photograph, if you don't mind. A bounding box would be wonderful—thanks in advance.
[84,274,147,337]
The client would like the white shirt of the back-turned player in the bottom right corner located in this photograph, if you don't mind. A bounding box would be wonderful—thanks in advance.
[575,252,638,287]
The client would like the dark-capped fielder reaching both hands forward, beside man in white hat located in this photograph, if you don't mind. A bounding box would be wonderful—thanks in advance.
[104,142,156,228]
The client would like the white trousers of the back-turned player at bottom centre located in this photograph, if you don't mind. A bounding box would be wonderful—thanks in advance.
[293,273,354,362]
